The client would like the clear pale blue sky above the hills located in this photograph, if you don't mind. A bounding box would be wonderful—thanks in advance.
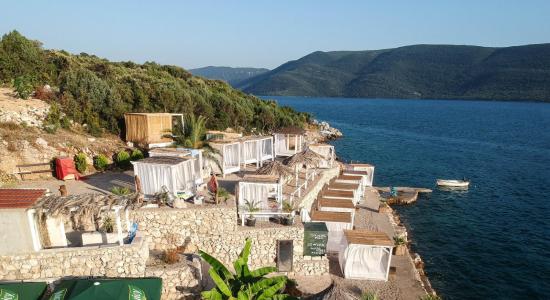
[0,0,550,69]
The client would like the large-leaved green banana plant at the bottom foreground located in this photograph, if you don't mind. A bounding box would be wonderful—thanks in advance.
[199,238,297,300]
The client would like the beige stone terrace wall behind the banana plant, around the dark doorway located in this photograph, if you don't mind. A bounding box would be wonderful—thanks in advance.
[131,207,328,275]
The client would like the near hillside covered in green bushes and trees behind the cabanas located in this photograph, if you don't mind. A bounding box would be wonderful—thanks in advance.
[0,31,309,135]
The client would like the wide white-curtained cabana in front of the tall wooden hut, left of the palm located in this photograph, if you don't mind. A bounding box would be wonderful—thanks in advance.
[132,156,196,195]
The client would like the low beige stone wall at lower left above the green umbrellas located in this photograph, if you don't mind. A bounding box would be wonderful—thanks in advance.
[0,236,149,280]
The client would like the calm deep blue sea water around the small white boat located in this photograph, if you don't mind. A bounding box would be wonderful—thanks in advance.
[268,97,550,299]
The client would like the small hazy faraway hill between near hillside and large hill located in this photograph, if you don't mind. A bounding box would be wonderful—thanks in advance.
[189,66,269,86]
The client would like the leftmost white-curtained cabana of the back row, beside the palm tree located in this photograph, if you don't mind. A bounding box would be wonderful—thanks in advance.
[209,140,241,176]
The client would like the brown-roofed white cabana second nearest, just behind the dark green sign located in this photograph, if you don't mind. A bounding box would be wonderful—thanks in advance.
[311,210,353,252]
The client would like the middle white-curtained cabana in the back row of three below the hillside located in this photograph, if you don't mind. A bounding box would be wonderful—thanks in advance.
[241,136,275,167]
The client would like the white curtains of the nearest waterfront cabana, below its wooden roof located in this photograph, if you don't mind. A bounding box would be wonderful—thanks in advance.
[338,244,391,280]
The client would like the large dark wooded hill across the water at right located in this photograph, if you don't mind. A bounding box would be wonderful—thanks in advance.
[236,44,550,101]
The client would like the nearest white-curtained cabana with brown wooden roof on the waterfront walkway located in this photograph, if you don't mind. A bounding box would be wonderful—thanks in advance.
[338,229,394,281]
